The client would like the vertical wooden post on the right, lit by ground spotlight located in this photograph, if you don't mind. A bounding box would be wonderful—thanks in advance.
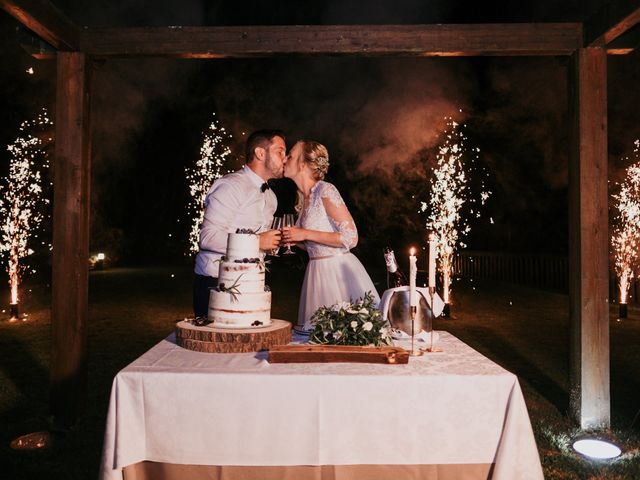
[569,48,610,428]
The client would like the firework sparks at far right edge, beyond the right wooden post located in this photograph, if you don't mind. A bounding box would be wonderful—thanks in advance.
[611,140,640,303]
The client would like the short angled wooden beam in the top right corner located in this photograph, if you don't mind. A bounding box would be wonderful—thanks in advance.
[584,0,640,47]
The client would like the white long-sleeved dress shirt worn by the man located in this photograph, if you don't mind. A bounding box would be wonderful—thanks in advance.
[195,165,278,277]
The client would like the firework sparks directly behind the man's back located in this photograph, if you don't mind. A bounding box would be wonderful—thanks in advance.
[185,113,231,255]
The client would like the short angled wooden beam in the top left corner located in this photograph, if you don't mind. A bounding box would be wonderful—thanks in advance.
[0,0,80,50]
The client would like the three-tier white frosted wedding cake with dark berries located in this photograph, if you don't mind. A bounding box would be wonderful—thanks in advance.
[208,230,271,328]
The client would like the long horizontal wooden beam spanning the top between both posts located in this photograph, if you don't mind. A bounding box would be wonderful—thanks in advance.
[81,23,582,58]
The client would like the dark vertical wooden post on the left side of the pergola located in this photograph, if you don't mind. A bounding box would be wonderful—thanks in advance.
[50,52,91,428]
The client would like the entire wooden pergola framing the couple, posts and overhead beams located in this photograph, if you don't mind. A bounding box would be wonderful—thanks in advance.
[0,0,640,428]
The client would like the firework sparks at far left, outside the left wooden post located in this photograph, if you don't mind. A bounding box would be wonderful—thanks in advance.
[0,109,53,318]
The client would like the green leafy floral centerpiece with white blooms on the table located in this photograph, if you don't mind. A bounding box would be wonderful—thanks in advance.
[309,292,393,347]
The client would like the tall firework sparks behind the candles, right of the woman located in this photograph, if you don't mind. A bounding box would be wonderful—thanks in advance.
[421,118,491,303]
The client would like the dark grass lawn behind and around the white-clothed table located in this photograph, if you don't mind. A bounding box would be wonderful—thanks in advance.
[0,256,640,480]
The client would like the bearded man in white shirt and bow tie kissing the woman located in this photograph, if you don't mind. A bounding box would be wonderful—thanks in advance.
[193,130,287,317]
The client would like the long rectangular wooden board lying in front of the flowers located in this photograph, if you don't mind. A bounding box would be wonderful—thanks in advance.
[268,345,409,365]
